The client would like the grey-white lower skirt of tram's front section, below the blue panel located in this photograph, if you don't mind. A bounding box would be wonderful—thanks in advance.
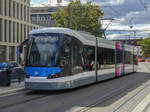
[25,74,95,90]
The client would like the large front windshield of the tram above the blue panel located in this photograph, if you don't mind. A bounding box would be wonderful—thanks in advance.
[26,33,63,67]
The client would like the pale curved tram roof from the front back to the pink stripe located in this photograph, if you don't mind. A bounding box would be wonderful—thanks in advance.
[30,27,132,50]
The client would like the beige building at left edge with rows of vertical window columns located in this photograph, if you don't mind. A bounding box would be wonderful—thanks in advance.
[0,0,39,62]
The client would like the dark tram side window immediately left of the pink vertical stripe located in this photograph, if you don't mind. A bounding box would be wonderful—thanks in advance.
[97,48,115,69]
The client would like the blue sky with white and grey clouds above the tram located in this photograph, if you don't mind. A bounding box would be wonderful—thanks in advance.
[31,0,150,39]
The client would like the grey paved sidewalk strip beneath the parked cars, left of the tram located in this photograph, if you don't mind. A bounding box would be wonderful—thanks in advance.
[0,82,24,95]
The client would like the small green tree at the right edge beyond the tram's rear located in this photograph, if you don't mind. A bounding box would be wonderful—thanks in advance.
[138,36,150,58]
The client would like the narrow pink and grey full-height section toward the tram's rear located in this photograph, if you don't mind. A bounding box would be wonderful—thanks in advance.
[115,41,124,76]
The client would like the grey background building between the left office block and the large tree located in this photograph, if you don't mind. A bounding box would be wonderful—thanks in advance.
[31,6,58,27]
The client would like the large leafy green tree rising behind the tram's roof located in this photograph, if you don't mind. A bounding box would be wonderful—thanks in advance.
[52,0,103,37]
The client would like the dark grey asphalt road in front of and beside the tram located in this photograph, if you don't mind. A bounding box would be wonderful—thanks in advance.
[0,63,150,112]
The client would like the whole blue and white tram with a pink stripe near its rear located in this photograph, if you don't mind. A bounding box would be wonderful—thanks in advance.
[20,28,136,90]
